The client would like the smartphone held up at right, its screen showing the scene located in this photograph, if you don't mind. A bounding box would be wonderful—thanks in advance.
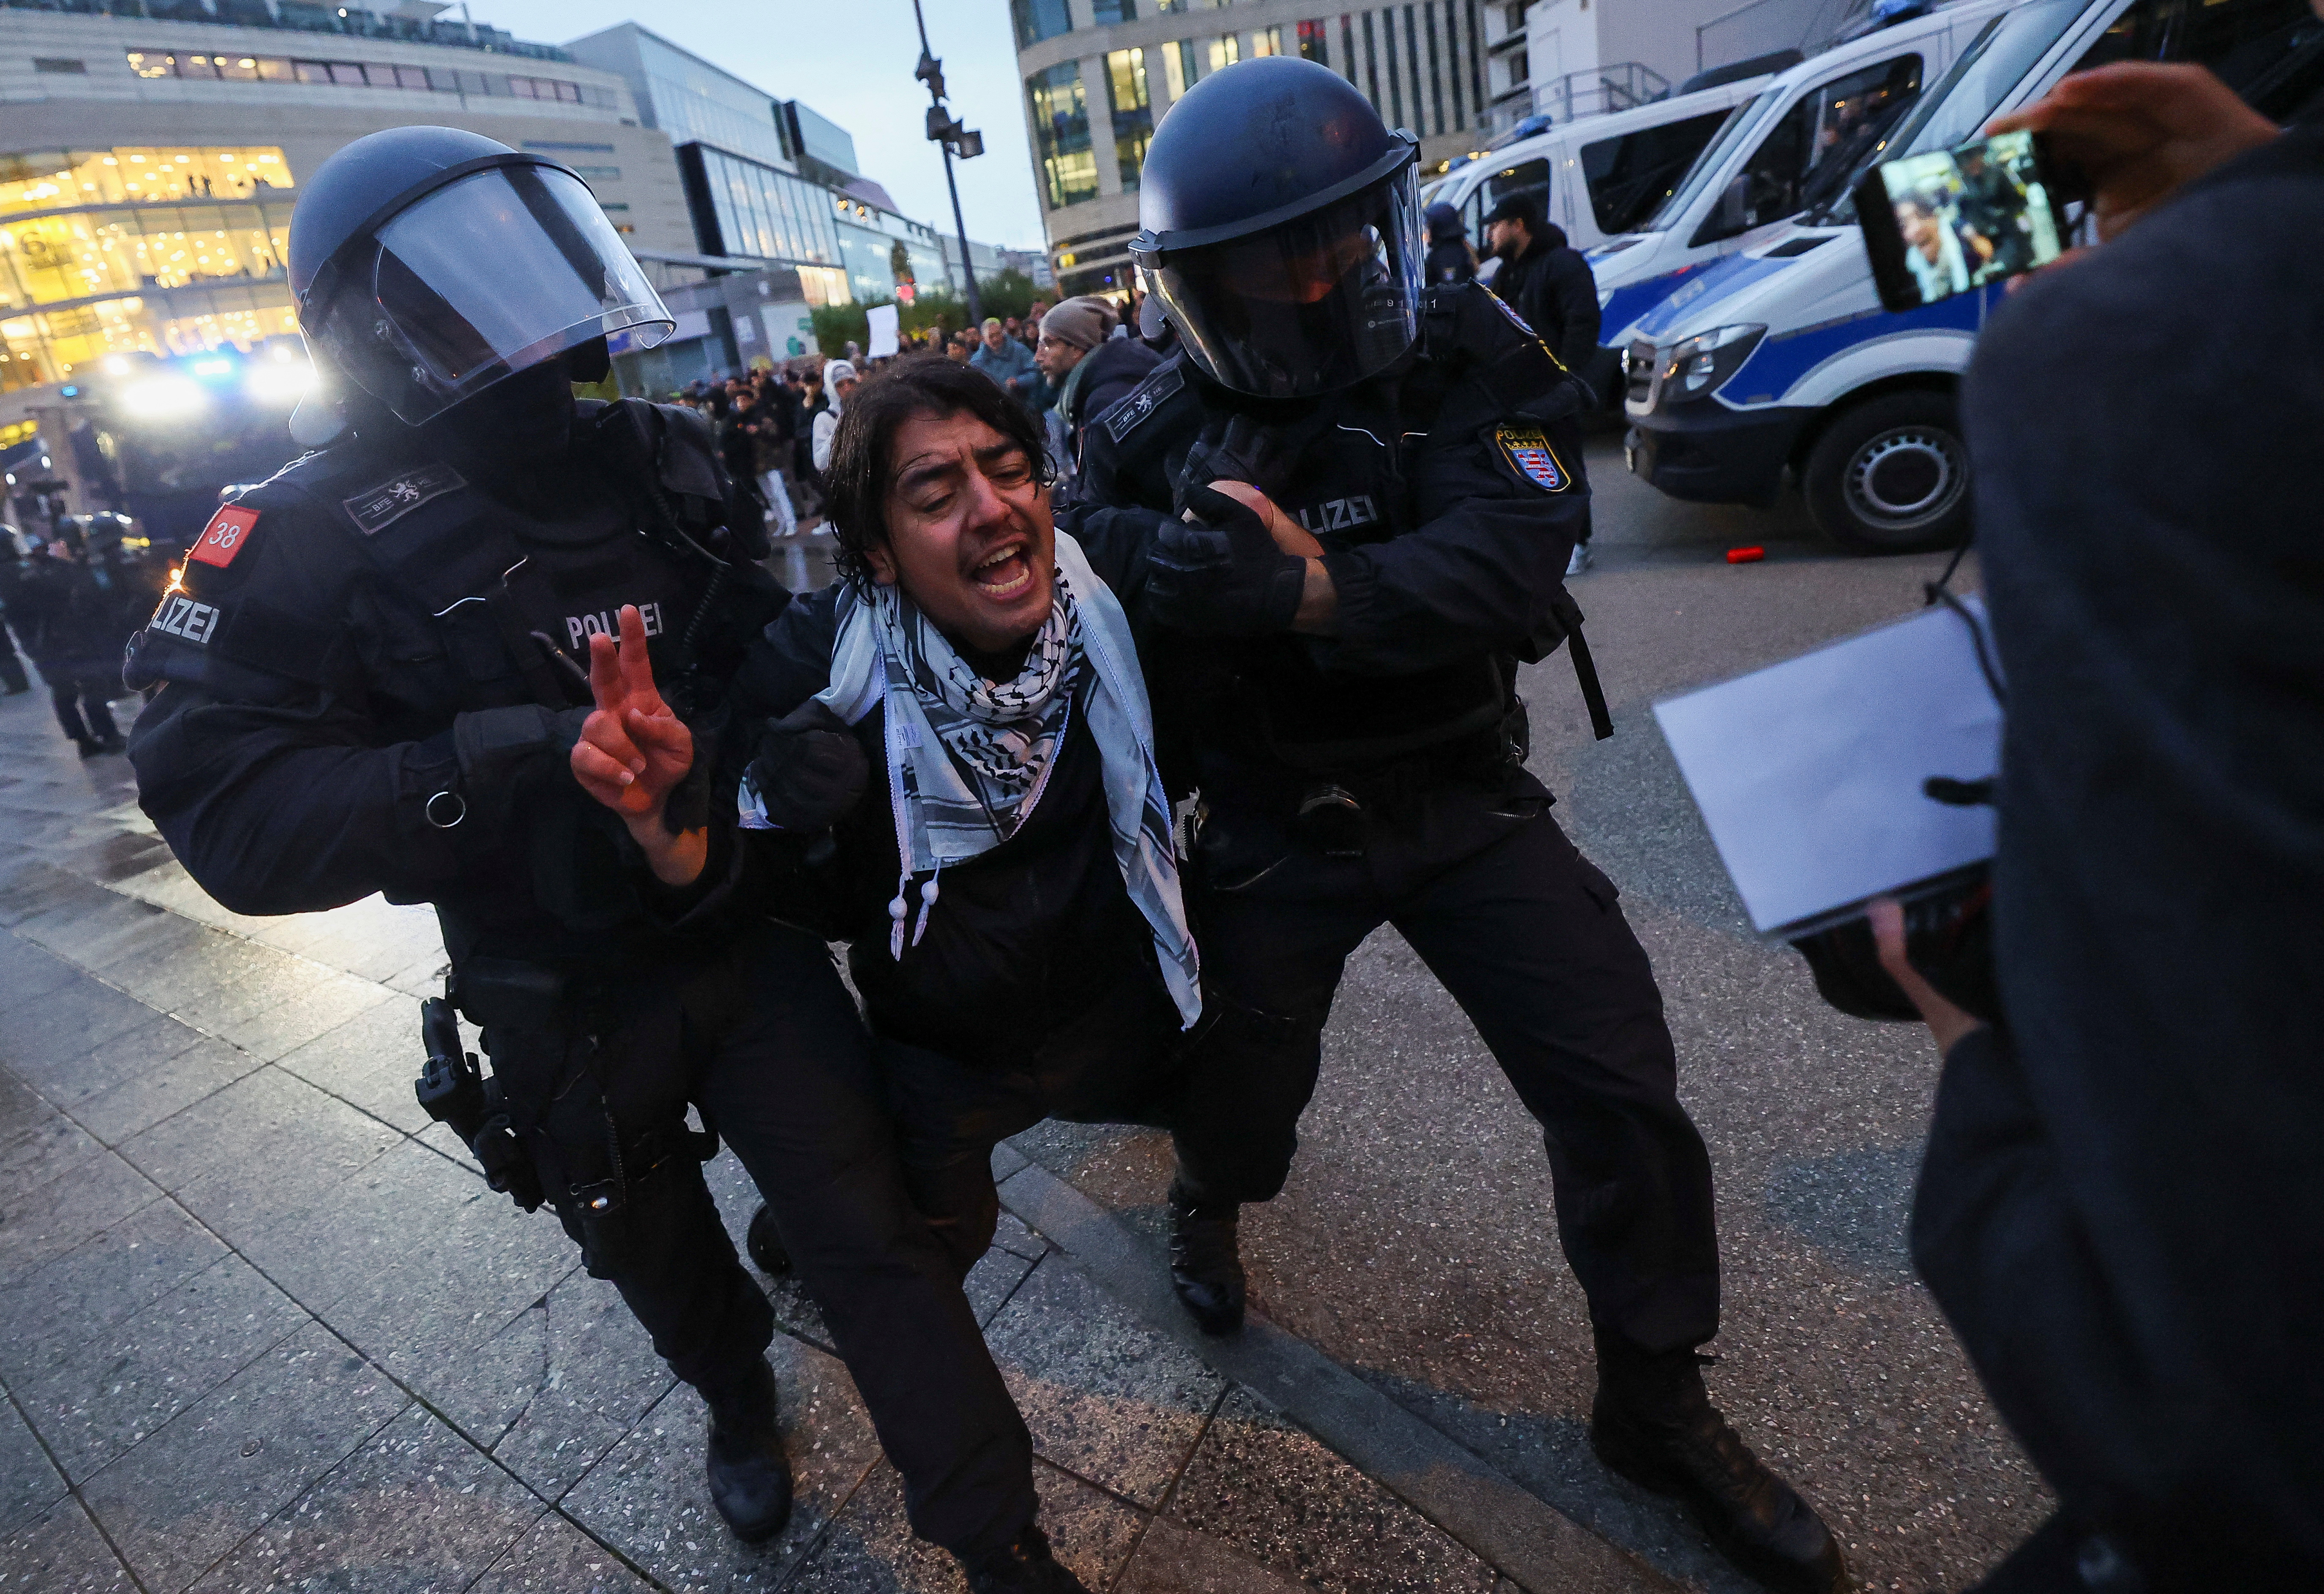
[1857,133,2068,309]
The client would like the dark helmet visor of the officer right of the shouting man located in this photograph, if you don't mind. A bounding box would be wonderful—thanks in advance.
[1141,165,1427,398]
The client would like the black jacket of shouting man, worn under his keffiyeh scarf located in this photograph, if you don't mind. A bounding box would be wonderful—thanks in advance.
[720,509,1162,1067]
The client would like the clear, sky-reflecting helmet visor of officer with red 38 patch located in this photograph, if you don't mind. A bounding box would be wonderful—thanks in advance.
[311,165,676,425]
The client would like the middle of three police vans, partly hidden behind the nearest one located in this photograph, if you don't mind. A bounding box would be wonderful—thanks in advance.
[1590,0,2022,369]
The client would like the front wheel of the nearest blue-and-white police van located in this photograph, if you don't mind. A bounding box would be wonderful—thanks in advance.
[1801,393,1969,553]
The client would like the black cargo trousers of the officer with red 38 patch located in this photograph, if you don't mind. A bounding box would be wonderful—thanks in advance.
[486,925,1037,1555]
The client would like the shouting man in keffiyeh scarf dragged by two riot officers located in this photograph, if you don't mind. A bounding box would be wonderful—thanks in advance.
[574,358,1227,1589]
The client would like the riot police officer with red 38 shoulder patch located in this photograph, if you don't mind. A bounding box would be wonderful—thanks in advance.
[130,128,1023,1541]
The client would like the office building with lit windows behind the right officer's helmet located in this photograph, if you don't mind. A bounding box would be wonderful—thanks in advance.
[1011,0,1506,293]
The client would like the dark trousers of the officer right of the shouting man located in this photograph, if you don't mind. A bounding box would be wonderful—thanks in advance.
[1185,779,1720,1350]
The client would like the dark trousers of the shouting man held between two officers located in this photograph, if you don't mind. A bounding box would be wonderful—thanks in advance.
[878,983,1199,1278]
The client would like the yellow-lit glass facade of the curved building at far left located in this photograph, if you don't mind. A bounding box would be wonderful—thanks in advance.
[0,147,297,390]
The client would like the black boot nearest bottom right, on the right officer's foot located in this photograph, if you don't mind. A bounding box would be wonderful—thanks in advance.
[1590,1334,1855,1594]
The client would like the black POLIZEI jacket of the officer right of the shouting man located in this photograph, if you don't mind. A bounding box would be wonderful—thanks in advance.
[1078,283,1590,802]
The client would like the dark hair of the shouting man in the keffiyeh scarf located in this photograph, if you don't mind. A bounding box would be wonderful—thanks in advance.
[823,353,1055,586]
